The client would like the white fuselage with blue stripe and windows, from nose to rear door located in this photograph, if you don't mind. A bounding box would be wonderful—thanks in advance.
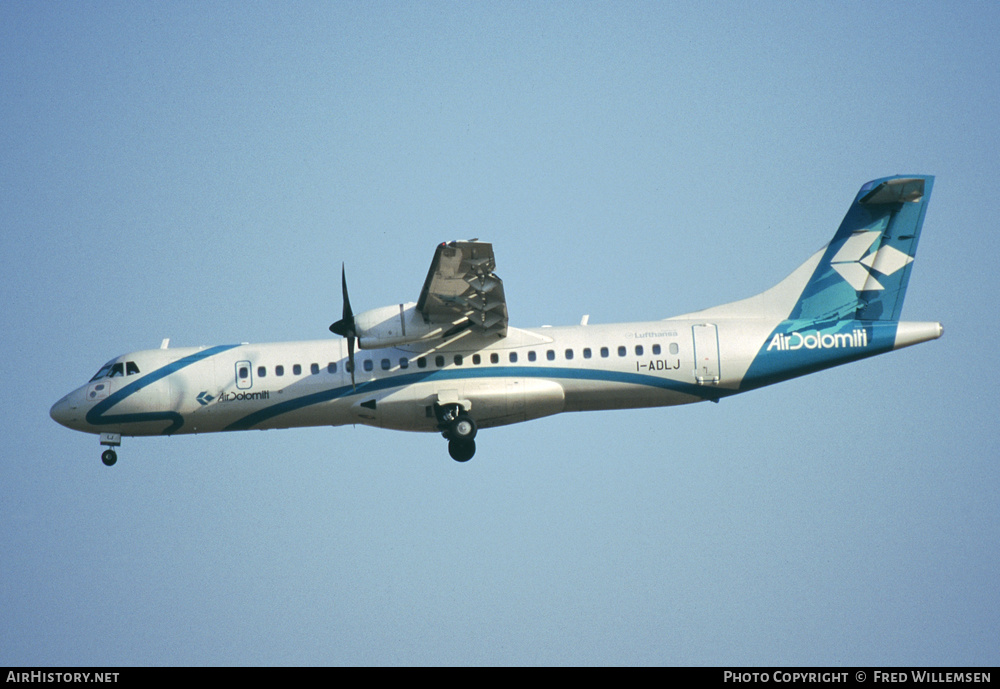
[53,320,748,436]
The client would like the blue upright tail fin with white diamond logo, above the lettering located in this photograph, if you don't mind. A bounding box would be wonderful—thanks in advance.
[788,175,934,321]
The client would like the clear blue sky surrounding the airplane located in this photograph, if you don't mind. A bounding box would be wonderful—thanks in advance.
[0,2,1000,665]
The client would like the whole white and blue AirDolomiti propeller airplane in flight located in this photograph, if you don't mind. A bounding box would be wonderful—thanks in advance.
[50,175,944,466]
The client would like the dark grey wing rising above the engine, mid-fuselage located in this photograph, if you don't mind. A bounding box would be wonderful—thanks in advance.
[417,240,507,337]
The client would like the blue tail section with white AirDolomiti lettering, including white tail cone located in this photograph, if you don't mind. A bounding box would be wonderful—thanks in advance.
[740,176,942,390]
